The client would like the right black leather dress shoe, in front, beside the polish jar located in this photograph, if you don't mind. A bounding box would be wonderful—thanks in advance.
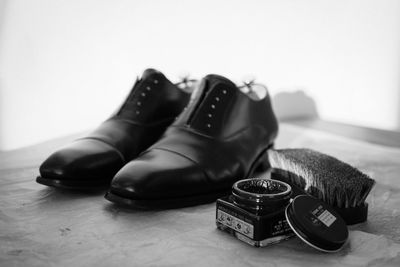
[105,75,278,208]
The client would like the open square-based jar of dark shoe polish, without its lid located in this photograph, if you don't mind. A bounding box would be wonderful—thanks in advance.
[216,178,294,247]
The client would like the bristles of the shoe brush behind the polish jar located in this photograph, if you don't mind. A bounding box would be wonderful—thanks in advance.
[268,149,375,208]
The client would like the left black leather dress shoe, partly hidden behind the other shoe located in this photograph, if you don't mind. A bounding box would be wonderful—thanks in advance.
[36,69,190,191]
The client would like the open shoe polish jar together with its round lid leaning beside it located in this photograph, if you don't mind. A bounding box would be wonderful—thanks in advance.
[216,178,348,252]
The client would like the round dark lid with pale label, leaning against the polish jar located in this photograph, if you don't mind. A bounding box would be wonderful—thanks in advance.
[285,195,349,252]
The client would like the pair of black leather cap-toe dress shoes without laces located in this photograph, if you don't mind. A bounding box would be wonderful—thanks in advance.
[37,69,278,208]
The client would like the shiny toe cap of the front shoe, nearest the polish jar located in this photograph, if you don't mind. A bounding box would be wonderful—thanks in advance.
[111,149,207,199]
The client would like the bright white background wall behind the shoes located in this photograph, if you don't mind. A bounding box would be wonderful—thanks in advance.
[0,0,400,149]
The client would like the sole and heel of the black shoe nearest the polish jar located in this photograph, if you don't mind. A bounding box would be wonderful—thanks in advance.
[104,144,273,210]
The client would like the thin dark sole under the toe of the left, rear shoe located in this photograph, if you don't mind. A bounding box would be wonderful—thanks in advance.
[36,176,111,190]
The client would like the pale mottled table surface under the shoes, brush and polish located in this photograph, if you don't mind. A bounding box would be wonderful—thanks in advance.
[0,124,400,266]
